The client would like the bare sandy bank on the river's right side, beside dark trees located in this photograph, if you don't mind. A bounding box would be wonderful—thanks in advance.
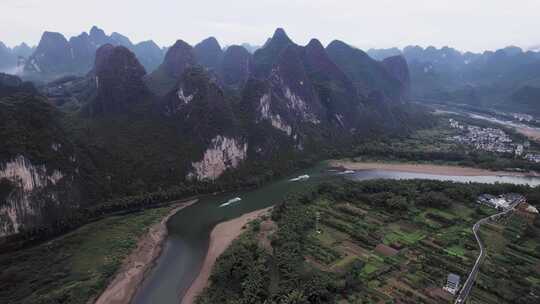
[181,207,271,304]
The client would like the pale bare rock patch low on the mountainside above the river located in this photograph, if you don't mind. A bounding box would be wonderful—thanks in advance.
[188,135,248,180]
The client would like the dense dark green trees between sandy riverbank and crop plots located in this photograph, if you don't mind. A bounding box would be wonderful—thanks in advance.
[197,191,341,304]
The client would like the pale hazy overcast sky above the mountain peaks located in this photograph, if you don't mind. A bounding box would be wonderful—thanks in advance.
[0,0,540,51]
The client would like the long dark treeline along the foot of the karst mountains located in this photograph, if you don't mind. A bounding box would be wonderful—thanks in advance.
[0,147,326,253]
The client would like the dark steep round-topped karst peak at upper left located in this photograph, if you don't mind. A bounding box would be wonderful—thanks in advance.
[89,44,148,115]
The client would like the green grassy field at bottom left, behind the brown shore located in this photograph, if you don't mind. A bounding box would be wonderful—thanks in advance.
[0,207,172,304]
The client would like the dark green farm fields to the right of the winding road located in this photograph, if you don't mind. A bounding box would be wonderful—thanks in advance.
[469,211,540,304]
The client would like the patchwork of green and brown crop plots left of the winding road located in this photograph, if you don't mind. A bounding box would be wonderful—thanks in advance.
[306,189,486,303]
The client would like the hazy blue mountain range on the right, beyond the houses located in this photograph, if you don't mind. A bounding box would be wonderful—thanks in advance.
[368,46,540,115]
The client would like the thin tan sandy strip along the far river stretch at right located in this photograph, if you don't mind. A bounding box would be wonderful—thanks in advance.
[328,160,538,176]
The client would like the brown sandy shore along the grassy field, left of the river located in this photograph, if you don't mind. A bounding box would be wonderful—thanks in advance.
[93,199,198,304]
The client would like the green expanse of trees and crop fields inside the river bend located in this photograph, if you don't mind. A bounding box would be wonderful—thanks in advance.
[197,180,540,304]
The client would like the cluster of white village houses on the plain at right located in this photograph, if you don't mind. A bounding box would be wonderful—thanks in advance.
[449,118,540,163]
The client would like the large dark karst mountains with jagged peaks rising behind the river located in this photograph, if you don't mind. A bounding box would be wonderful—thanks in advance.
[0,28,424,242]
